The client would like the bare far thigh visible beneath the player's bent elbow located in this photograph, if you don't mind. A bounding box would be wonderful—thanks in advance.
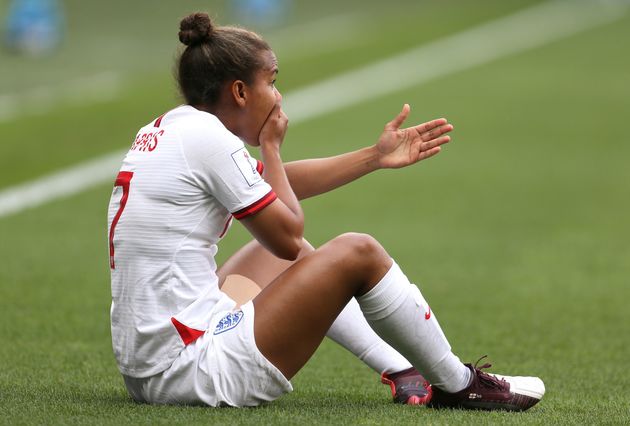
[217,240,314,288]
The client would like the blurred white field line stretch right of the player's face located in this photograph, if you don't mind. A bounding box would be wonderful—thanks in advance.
[283,0,628,123]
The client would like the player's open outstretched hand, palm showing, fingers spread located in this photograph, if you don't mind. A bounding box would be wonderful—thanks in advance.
[376,104,453,169]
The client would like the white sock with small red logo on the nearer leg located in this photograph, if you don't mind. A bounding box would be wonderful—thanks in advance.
[357,262,471,392]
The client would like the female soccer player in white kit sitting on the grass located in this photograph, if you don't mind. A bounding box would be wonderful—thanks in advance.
[109,13,544,410]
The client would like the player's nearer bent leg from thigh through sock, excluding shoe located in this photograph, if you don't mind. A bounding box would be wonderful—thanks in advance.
[254,234,470,391]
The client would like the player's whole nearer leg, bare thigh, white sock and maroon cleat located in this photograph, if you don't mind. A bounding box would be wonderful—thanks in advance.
[254,234,544,410]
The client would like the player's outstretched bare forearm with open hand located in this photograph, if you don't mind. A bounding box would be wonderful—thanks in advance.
[282,104,453,199]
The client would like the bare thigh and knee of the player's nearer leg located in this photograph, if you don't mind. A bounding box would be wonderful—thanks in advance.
[254,234,392,378]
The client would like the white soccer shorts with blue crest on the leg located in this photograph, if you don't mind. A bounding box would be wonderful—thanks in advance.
[123,301,293,407]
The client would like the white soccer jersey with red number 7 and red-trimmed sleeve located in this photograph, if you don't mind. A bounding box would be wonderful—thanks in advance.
[108,105,276,377]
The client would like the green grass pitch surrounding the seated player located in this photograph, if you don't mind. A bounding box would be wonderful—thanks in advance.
[0,0,630,425]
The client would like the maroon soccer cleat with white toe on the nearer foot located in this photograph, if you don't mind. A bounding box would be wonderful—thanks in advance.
[428,357,545,411]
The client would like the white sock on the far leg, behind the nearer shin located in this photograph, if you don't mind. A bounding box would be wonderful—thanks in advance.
[326,298,411,374]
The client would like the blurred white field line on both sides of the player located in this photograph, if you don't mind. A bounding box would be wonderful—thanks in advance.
[0,0,629,217]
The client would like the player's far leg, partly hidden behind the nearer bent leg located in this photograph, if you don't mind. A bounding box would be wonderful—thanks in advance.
[219,240,431,405]
